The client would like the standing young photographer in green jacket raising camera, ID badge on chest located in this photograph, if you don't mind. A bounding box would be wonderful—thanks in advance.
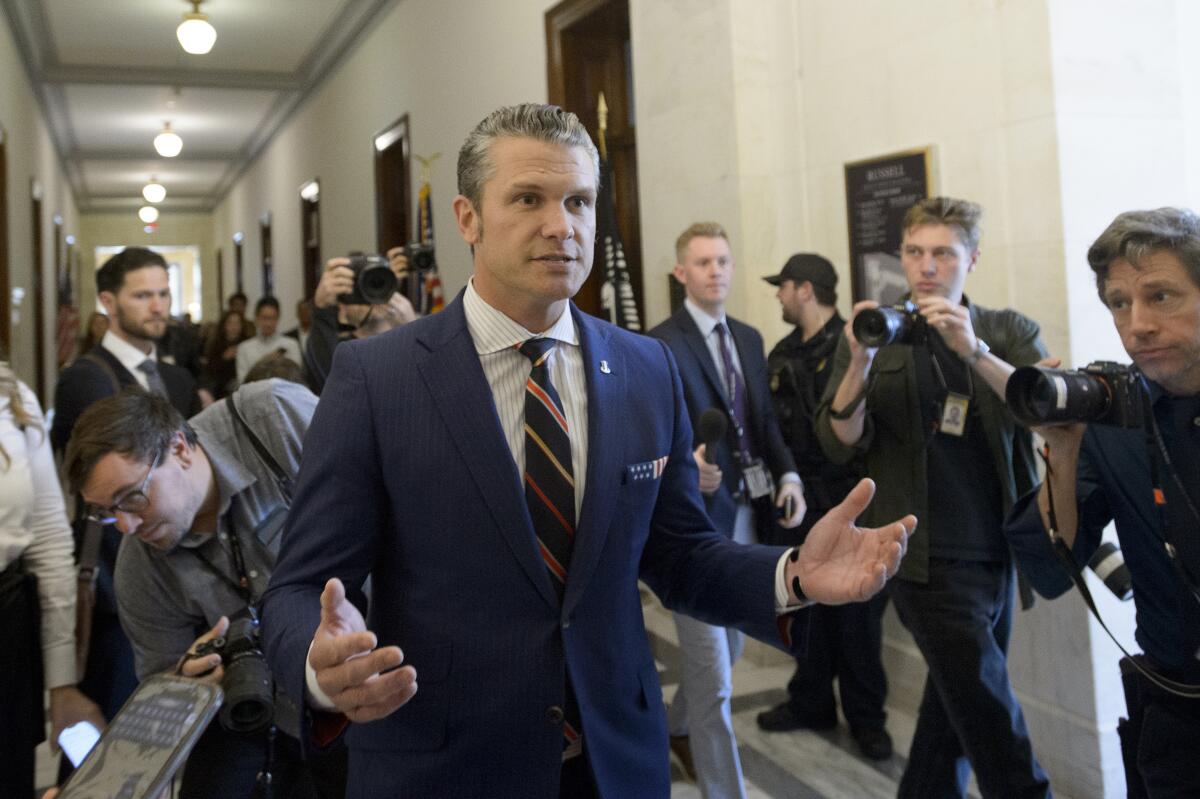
[816,197,1050,799]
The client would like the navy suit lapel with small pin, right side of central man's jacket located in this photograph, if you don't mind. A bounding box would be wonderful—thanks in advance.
[563,304,628,618]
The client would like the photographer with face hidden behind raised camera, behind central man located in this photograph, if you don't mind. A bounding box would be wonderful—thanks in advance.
[304,247,419,394]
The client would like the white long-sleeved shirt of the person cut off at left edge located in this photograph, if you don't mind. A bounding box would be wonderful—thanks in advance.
[0,379,76,689]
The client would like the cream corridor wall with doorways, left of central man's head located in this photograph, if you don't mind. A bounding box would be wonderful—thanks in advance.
[214,0,553,326]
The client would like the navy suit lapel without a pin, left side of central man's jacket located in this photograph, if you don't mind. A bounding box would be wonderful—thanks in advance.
[418,294,558,608]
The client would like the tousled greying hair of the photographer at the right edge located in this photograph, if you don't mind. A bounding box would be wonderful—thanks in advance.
[1087,208,1200,305]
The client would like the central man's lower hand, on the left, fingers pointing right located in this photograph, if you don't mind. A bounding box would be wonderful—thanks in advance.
[308,577,416,721]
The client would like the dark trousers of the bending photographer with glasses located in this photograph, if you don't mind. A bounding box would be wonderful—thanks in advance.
[179,721,347,799]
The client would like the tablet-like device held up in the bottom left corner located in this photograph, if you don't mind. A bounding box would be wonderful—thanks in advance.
[59,674,223,799]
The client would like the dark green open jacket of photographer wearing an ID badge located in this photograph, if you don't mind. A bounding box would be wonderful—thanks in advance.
[816,298,1046,583]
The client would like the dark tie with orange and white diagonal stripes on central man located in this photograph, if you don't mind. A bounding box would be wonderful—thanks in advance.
[518,338,583,761]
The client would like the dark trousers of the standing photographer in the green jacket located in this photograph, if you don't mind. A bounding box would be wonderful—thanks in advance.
[890,558,1050,799]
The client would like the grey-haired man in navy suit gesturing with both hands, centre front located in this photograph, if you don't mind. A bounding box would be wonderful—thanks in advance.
[264,104,916,799]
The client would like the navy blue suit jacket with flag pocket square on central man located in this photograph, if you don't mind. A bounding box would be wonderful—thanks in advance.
[264,295,799,799]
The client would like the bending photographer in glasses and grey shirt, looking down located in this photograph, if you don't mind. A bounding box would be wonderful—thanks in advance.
[65,380,344,798]
